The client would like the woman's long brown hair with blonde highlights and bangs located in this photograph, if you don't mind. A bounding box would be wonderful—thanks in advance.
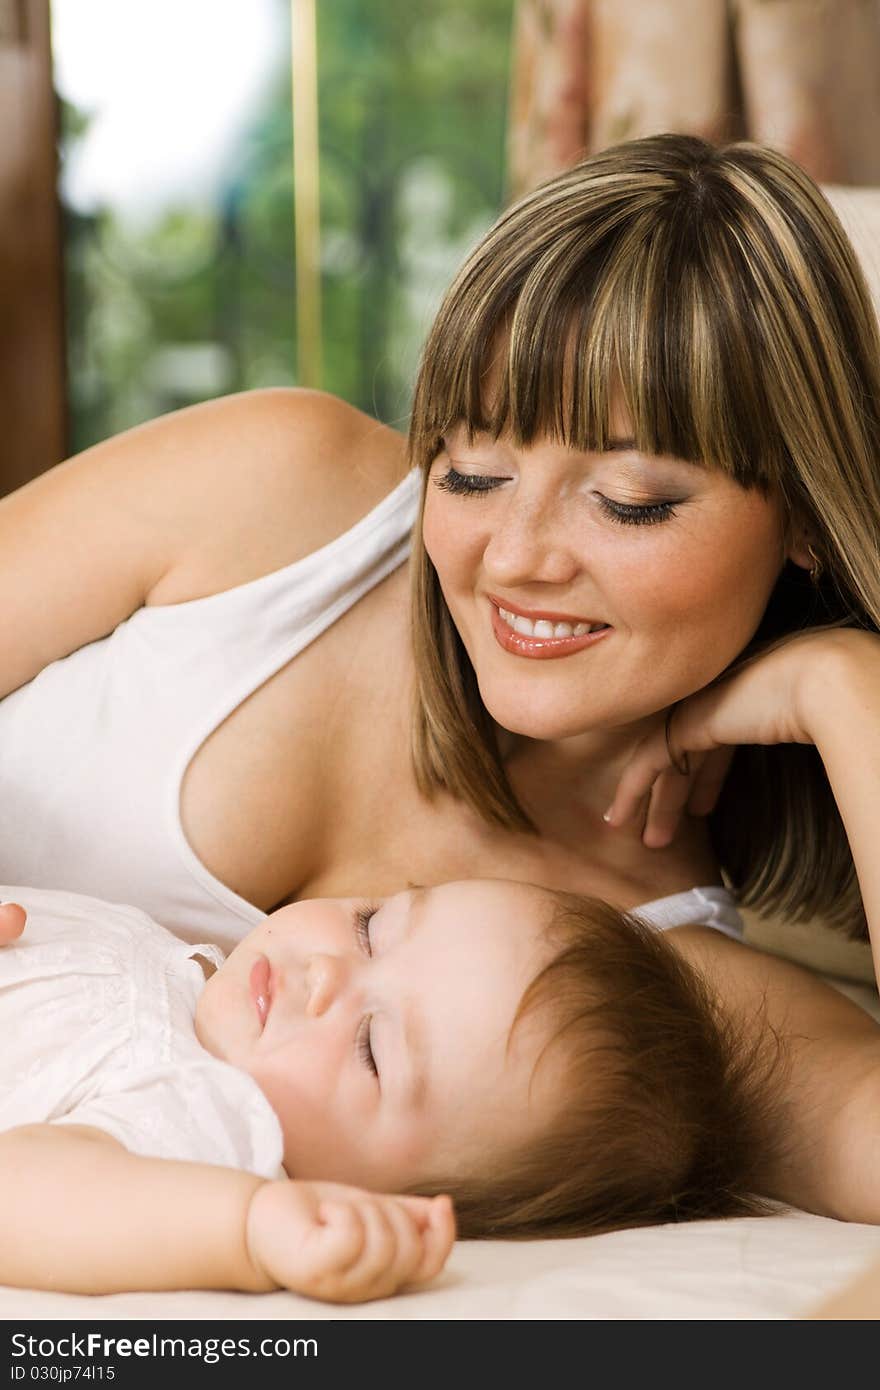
[410,135,880,934]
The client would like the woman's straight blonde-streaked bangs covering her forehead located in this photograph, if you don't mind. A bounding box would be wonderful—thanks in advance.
[410,177,787,488]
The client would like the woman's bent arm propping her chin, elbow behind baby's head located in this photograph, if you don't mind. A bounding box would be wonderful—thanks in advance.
[608,628,880,1222]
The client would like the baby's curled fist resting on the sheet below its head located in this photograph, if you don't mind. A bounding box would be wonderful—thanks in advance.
[246,1180,455,1302]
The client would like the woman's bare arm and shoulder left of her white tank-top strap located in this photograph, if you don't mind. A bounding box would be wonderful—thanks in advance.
[0,389,405,696]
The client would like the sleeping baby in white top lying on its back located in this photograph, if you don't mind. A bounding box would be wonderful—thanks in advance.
[0,880,766,1301]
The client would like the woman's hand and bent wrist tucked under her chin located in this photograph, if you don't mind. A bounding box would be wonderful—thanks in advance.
[605,628,861,849]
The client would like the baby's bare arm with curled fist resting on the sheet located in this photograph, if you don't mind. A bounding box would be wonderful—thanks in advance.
[0,1125,455,1302]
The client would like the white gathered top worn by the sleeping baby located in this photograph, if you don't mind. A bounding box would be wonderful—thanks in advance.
[0,885,284,1177]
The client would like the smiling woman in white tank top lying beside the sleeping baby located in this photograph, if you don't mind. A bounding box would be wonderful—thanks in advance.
[0,136,880,945]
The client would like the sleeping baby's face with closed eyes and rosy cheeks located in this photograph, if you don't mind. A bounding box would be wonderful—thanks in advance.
[196,880,552,1191]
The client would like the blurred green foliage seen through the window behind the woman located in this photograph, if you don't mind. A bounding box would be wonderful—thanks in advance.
[61,0,512,450]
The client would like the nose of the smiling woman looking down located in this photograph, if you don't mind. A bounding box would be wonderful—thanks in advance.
[482,493,580,585]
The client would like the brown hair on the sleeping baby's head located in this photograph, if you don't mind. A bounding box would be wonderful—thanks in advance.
[418,892,783,1238]
